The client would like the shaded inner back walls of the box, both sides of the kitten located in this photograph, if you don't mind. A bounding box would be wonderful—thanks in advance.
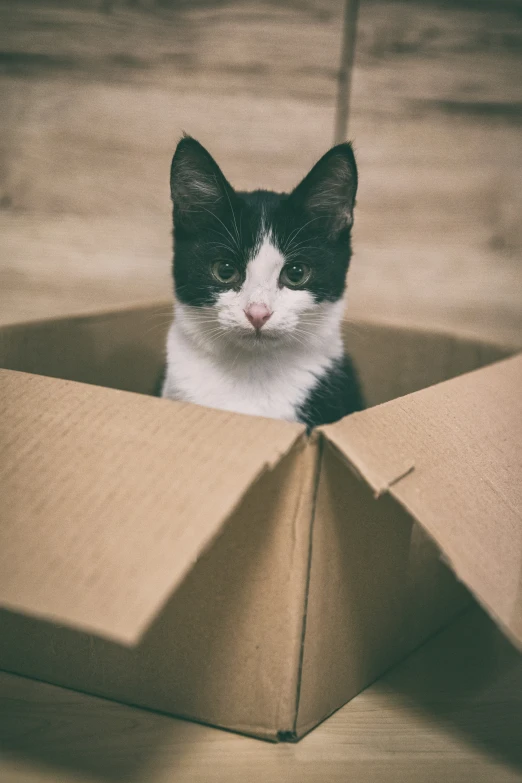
[0,302,513,405]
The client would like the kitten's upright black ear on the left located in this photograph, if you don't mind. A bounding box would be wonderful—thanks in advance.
[170,136,235,227]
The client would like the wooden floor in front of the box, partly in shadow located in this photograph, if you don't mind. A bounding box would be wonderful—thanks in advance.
[0,608,522,783]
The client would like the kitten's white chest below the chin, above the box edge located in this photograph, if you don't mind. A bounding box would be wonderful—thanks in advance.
[162,324,334,421]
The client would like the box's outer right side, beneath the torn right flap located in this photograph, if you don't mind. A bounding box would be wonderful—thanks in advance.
[297,444,469,736]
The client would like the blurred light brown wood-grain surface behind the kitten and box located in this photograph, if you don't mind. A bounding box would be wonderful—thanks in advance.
[0,0,522,342]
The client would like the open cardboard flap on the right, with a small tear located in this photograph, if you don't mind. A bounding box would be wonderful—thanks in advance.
[323,356,522,646]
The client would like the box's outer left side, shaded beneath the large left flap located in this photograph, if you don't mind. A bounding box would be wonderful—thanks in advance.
[0,444,316,739]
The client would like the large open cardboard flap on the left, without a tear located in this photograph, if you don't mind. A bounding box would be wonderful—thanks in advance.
[0,370,303,643]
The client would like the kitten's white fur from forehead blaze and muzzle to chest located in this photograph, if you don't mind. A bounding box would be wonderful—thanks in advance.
[162,233,344,421]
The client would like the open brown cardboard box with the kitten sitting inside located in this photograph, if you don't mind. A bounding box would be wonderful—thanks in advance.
[0,304,522,740]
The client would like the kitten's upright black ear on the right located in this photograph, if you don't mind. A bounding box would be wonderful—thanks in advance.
[289,142,357,238]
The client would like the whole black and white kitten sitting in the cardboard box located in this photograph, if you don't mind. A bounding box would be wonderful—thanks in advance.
[162,136,363,428]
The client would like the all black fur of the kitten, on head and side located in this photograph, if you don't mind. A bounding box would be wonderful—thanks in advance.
[161,137,364,430]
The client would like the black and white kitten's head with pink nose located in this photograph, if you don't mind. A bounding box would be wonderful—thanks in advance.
[170,136,357,351]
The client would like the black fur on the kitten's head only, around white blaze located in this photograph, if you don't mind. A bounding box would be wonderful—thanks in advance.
[171,137,357,307]
